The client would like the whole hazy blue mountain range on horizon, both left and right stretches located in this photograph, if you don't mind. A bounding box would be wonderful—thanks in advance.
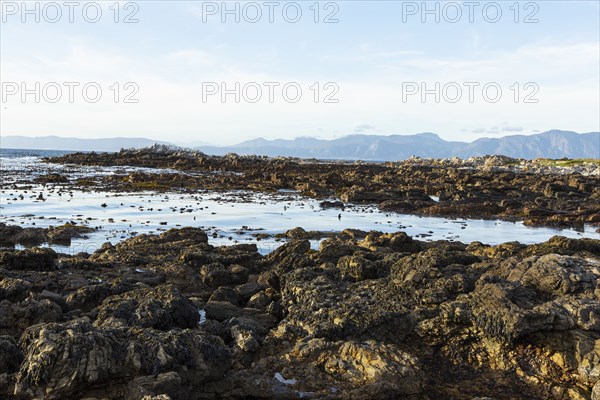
[0,130,600,161]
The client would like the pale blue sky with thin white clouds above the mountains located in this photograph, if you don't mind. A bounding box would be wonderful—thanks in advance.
[0,0,600,145]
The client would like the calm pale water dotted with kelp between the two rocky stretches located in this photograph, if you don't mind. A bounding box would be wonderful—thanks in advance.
[0,150,600,254]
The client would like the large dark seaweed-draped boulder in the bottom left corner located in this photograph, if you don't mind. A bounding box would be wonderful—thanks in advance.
[15,320,230,399]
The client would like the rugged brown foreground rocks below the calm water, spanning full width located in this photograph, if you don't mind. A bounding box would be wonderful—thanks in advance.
[0,228,600,400]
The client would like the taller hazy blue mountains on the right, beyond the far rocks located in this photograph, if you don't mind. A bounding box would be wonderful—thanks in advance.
[198,130,600,160]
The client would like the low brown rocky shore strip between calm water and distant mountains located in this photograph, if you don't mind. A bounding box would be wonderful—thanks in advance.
[47,146,600,229]
